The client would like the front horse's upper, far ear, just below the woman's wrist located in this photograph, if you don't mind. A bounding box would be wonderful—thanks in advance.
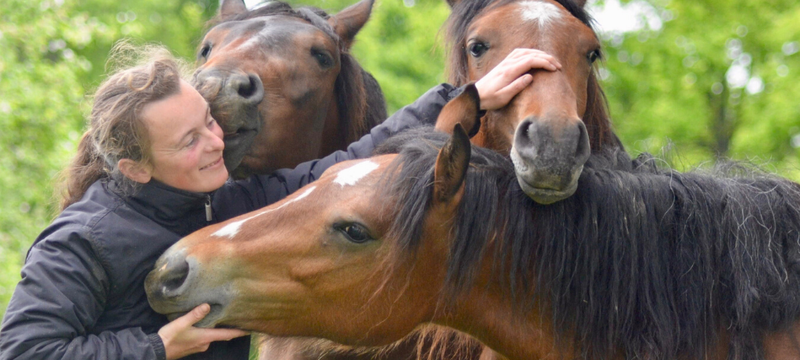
[436,83,481,137]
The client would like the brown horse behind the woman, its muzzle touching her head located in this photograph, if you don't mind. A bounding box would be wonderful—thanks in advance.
[194,0,386,177]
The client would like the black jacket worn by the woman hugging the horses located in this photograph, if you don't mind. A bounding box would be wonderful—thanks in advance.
[0,84,457,360]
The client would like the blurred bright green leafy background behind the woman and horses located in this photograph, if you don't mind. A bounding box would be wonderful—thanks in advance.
[0,0,800,338]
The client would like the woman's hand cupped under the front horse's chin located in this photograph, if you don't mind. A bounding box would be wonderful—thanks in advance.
[158,304,248,360]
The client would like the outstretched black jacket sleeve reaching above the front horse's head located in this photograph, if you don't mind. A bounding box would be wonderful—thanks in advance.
[214,84,462,221]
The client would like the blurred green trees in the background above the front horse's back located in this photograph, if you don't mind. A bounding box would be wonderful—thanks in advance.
[596,0,800,179]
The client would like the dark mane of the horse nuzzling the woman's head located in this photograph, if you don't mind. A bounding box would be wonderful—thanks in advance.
[206,1,387,144]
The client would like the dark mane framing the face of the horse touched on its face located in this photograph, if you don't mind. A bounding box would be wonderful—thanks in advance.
[445,0,623,153]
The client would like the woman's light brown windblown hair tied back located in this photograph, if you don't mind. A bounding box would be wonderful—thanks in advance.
[61,40,187,210]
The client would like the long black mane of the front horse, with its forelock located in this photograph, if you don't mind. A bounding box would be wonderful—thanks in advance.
[378,129,800,360]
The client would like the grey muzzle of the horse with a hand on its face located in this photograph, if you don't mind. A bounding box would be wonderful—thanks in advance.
[510,117,591,205]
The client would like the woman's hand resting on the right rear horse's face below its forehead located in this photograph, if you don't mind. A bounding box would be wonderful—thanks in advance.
[475,49,561,110]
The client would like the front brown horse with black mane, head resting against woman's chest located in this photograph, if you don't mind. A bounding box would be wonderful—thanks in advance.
[146,86,800,360]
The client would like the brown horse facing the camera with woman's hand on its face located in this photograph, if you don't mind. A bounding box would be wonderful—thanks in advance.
[437,0,622,204]
